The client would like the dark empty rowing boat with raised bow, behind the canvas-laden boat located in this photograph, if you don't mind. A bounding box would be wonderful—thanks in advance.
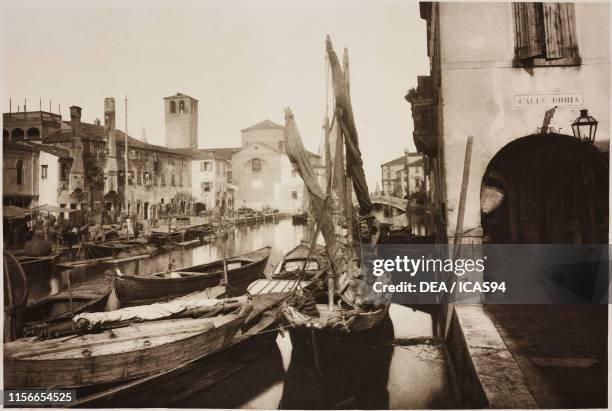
[114,247,271,304]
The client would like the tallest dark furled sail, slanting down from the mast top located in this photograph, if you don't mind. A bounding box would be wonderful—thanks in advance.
[325,36,372,215]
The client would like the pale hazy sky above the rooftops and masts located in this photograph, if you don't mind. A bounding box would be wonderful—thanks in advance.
[0,0,429,191]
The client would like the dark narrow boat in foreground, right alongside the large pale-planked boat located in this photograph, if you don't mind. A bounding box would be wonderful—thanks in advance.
[71,295,280,408]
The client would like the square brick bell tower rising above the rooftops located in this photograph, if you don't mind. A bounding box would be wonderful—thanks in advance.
[164,93,198,149]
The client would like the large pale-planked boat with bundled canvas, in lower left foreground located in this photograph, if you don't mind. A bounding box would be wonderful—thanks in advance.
[4,296,253,389]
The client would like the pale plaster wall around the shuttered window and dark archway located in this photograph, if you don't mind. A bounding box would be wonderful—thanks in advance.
[439,3,610,238]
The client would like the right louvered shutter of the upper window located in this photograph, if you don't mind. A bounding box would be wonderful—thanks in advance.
[544,3,578,59]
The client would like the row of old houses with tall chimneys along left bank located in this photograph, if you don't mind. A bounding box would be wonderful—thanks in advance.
[3,99,193,219]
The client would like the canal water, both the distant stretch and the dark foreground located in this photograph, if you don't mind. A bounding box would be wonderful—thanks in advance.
[29,219,460,409]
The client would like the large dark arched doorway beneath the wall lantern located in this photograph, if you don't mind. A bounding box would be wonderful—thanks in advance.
[481,133,609,244]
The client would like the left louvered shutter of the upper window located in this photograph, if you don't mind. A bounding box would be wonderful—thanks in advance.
[513,3,544,60]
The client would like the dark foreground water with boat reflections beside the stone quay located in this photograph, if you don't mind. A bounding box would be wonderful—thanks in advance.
[176,305,460,409]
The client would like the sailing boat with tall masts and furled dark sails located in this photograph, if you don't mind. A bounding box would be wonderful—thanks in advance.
[281,36,390,370]
